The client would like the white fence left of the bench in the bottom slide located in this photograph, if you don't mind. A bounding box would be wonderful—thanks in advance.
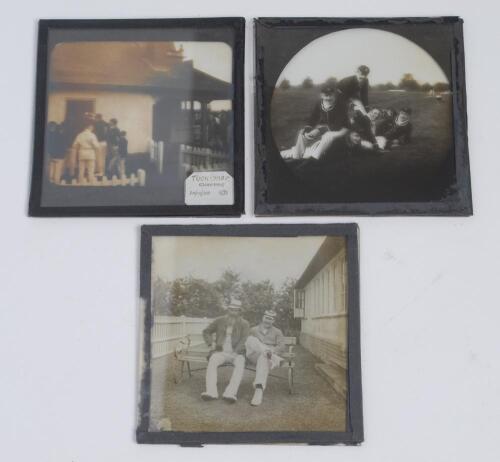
[151,316,212,359]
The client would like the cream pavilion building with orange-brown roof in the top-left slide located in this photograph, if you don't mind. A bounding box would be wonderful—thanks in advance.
[47,41,233,173]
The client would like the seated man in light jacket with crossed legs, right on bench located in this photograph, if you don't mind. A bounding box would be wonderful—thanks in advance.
[245,310,285,406]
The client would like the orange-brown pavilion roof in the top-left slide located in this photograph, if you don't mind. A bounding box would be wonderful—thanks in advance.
[49,42,232,100]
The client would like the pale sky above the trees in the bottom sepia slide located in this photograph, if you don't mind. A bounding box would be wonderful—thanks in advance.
[152,236,325,287]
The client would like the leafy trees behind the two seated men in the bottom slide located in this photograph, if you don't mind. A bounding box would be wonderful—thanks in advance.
[152,269,300,335]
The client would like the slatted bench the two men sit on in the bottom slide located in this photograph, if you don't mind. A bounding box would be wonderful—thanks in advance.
[174,335,297,394]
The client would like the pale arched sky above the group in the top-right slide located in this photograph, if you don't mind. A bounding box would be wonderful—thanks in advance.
[277,28,448,85]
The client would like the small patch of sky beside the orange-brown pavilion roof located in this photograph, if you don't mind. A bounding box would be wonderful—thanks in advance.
[175,42,233,83]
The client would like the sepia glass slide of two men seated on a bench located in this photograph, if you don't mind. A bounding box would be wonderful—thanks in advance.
[138,225,361,443]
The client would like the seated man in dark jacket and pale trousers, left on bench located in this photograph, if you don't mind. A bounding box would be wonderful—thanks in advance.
[201,298,250,403]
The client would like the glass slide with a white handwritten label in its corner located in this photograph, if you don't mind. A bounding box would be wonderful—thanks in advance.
[30,18,244,215]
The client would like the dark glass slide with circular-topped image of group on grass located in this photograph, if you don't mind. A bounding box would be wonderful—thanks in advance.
[256,18,472,215]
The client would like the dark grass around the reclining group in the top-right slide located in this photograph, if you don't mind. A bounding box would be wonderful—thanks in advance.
[271,88,454,202]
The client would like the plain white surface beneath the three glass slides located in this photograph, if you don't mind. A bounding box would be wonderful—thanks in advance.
[0,0,500,462]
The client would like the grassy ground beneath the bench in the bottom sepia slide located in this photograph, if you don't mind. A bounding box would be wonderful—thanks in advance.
[150,346,346,432]
